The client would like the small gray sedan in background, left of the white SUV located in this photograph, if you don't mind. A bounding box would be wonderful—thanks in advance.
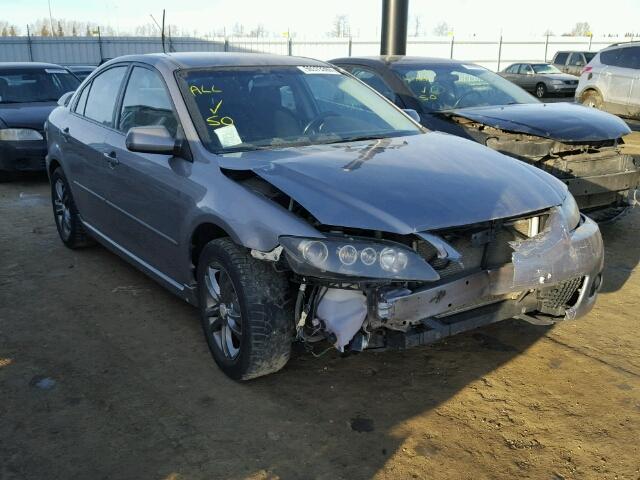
[500,63,578,98]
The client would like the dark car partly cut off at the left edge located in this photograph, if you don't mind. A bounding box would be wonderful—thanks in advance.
[0,63,80,181]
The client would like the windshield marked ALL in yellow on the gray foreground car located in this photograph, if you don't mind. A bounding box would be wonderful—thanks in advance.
[178,66,421,153]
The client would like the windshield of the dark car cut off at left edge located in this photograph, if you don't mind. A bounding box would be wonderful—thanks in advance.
[0,68,80,103]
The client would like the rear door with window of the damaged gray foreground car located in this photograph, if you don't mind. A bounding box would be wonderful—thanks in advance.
[61,65,128,231]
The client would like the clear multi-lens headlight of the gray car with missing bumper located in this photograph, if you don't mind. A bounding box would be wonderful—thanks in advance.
[280,237,440,282]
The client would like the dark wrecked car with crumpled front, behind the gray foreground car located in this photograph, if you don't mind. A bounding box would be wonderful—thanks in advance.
[331,56,640,221]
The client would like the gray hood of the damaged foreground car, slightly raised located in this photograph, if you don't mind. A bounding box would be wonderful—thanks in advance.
[218,132,566,234]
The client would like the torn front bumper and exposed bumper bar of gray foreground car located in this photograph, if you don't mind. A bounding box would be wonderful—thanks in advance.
[377,216,604,343]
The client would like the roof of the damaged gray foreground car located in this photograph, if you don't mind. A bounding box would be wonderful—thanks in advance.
[107,52,328,69]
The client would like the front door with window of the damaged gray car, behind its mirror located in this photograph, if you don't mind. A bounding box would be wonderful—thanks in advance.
[101,65,191,281]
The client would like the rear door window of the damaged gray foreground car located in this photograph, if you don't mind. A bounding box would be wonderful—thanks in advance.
[84,66,127,127]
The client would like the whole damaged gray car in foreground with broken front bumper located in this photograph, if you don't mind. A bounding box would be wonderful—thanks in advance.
[47,53,603,380]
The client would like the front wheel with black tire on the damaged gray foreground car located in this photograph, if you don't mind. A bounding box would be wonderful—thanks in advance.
[197,238,294,380]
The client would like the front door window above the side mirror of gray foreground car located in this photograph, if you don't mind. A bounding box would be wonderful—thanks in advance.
[118,67,178,137]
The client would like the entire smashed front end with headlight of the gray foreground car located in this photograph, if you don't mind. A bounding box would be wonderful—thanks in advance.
[253,195,603,351]
